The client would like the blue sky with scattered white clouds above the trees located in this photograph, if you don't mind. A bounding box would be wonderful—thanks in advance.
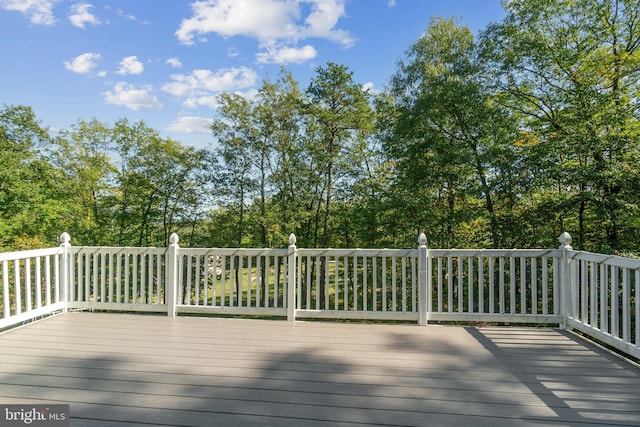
[0,0,505,148]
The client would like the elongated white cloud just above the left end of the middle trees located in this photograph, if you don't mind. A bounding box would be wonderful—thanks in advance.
[162,67,258,97]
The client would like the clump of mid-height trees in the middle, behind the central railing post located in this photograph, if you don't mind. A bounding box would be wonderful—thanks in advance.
[212,64,373,247]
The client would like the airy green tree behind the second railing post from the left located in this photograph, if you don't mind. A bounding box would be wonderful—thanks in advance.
[110,119,207,246]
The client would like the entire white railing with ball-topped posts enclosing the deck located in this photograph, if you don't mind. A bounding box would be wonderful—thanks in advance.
[0,233,640,358]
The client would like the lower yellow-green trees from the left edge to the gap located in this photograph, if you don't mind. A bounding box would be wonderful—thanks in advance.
[0,110,211,250]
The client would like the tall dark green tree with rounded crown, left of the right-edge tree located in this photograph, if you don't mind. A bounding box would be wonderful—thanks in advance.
[385,18,515,247]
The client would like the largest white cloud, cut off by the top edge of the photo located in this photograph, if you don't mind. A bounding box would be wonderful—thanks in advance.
[175,0,354,62]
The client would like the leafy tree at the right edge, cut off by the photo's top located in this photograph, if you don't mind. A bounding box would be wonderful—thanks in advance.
[483,0,640,251]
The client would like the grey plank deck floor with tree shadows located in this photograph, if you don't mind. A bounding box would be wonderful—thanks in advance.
[0,313,640,427]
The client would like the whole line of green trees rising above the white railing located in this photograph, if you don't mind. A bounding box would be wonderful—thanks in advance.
[0,0,640,253]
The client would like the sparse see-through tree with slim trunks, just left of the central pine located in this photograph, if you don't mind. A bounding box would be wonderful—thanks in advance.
[212,69,330,251]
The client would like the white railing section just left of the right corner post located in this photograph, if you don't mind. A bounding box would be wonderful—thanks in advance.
[428,249,561,324]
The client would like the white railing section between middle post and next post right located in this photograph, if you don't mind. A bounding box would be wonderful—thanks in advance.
[295,249,418,321]
